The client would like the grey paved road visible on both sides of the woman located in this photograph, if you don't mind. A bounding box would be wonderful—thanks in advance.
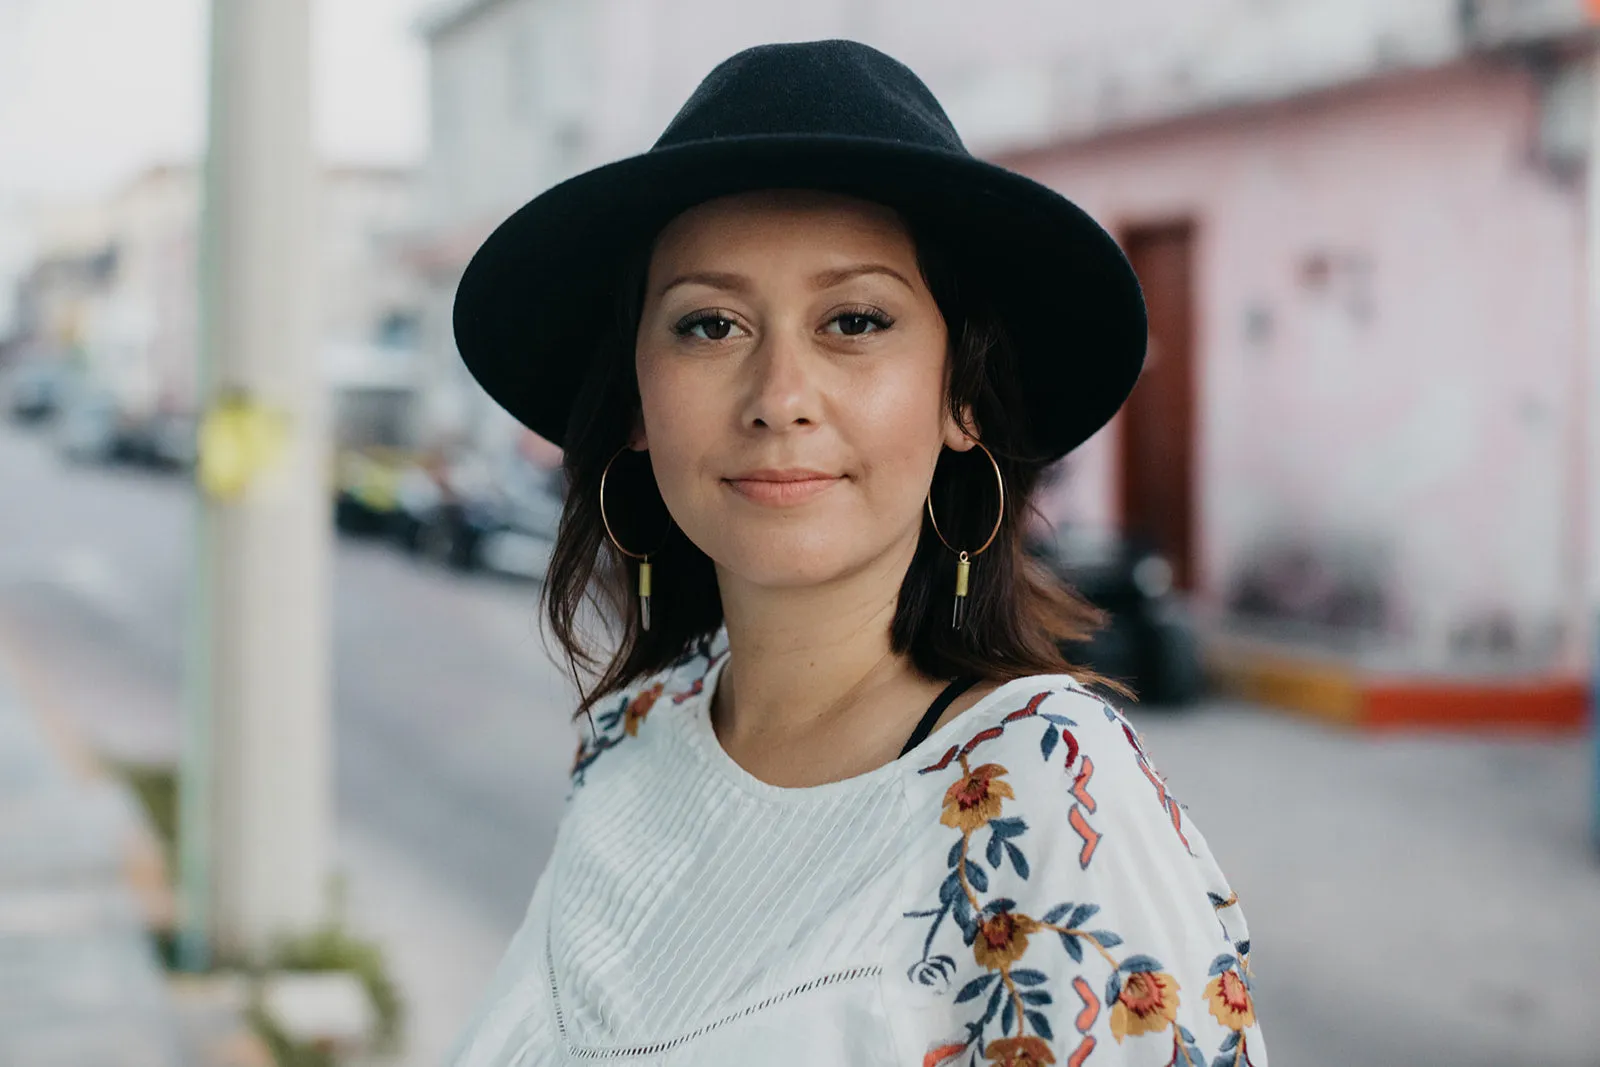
[0,430,1600,1067]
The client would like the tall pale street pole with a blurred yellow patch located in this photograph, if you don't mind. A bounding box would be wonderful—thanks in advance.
[182,0,330,963]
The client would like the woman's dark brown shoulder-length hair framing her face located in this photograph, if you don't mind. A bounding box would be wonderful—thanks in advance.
[544,214,1120,715]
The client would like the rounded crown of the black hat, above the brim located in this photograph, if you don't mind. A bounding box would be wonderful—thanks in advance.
[654,40,966,155]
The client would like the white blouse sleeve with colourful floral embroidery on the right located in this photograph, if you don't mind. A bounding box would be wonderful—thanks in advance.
[886,685,1267,1067]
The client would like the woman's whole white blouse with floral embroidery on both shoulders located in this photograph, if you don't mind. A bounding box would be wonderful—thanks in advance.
[453,641,1267,1067]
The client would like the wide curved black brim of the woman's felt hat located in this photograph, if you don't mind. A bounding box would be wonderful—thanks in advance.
[454,136,1147,459]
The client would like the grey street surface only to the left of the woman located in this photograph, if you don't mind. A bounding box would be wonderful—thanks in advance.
[0,427,571,1064]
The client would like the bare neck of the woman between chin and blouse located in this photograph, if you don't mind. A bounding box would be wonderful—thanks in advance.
[715,541,922,741]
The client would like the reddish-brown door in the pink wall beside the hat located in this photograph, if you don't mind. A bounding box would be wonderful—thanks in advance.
[1122,222,1195,590]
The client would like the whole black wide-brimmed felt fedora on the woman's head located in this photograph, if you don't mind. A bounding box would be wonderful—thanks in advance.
[454,40,1146,459]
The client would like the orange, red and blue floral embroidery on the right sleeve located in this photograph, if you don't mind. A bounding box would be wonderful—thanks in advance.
[906,693,1254,1067]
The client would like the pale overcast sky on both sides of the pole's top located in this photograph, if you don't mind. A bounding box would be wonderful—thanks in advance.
[0,0,430,198]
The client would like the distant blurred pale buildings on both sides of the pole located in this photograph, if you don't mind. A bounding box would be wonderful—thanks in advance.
[16,163,422,443]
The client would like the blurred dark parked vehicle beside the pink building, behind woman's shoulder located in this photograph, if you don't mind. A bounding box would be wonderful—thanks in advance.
[1029,528,1205,704]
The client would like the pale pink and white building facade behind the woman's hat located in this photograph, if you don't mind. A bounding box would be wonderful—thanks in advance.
[413,0,1600,684]
